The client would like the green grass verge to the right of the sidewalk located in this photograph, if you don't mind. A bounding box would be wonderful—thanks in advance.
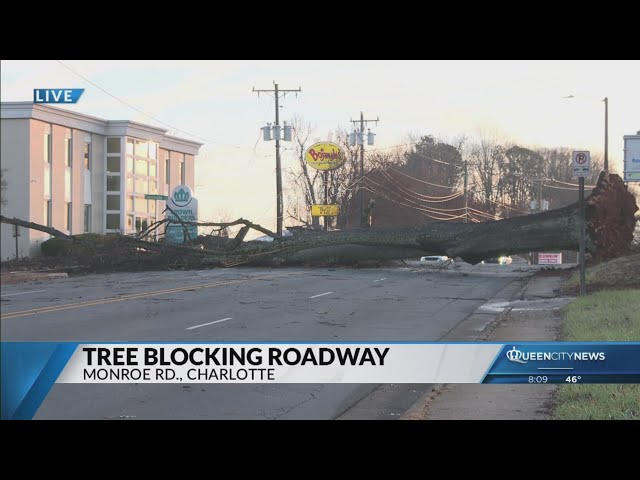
[553,289,640,420]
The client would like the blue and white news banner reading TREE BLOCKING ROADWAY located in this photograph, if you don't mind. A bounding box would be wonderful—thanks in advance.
[0,342,640,419]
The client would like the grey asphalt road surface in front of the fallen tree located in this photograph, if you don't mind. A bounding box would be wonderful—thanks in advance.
[0,265,526,419]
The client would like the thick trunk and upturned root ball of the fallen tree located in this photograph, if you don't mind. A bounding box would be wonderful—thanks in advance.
[272,172,638,264]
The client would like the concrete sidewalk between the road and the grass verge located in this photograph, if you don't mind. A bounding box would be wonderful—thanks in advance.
[401,274,571,420]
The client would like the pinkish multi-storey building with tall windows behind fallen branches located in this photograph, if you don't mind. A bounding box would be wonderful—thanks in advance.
[0,102,202,260]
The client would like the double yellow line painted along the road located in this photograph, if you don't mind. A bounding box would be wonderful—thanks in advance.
[0,272,304,320]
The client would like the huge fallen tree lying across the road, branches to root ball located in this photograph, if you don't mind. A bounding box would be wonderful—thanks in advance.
[0,172,638,269]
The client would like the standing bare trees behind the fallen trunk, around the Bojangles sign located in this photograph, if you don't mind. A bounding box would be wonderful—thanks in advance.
[285,118,603,229]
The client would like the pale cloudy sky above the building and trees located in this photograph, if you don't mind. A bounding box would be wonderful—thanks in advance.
[0,60,640,234]
